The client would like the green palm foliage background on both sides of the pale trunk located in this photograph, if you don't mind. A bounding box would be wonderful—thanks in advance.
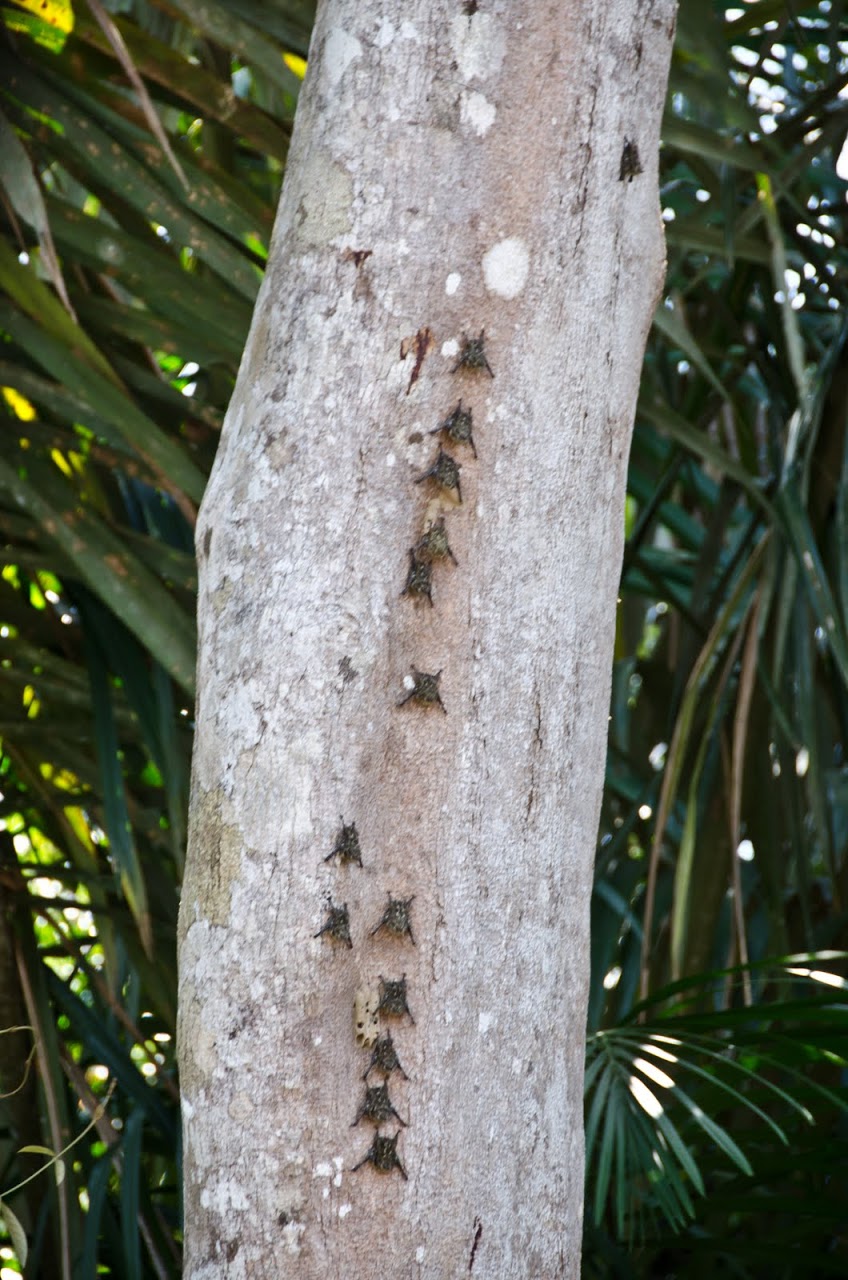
[0,0,848,1280]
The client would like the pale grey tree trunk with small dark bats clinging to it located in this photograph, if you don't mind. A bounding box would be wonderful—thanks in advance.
[179,0,674,1280]
